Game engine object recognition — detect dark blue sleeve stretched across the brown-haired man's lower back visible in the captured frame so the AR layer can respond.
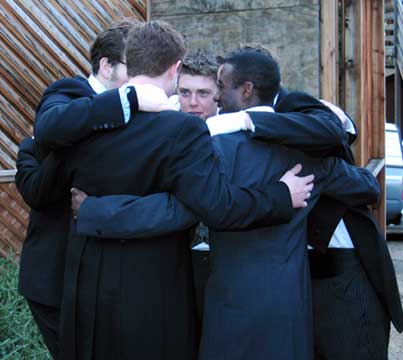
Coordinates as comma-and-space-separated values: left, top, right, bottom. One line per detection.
77, 193, 198, 239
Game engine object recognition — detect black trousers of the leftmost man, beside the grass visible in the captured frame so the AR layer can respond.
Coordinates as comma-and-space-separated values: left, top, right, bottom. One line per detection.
26, 299, 60, 359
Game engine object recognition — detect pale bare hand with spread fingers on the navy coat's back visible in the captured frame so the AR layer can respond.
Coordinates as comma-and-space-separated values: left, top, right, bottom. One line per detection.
280, 164, 314, 209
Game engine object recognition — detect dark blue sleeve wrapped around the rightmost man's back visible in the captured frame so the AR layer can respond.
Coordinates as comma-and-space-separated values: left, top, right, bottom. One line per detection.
323, 158, 381, 207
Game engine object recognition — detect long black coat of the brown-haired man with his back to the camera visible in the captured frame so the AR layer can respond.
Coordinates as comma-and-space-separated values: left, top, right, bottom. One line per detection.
54, 99, 293, 359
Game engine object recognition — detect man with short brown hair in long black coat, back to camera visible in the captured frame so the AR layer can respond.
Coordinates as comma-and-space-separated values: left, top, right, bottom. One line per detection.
35, 22, 318, 360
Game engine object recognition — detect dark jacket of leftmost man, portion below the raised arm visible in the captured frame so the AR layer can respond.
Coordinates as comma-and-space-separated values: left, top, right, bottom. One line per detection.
15, 138, 70, 307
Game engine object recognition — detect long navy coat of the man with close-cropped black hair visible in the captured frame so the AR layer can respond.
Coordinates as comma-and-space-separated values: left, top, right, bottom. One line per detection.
200, 128, 379, 360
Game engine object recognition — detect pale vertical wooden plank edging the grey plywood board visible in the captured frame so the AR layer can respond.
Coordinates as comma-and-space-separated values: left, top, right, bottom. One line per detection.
320, 1, 338, 104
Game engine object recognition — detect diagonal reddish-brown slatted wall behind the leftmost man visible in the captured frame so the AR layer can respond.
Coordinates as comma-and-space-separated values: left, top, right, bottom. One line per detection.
0, 0, 147, 254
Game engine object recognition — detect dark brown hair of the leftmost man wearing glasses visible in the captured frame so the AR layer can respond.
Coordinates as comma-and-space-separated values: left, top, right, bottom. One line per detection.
90, 19, 141, 75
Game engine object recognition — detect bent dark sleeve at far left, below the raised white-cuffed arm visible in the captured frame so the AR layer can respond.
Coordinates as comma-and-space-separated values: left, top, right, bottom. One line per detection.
15, 138, 66, 210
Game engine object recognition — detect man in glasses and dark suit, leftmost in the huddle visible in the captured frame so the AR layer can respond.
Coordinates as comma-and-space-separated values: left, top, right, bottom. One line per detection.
16, 21, 152, 357
